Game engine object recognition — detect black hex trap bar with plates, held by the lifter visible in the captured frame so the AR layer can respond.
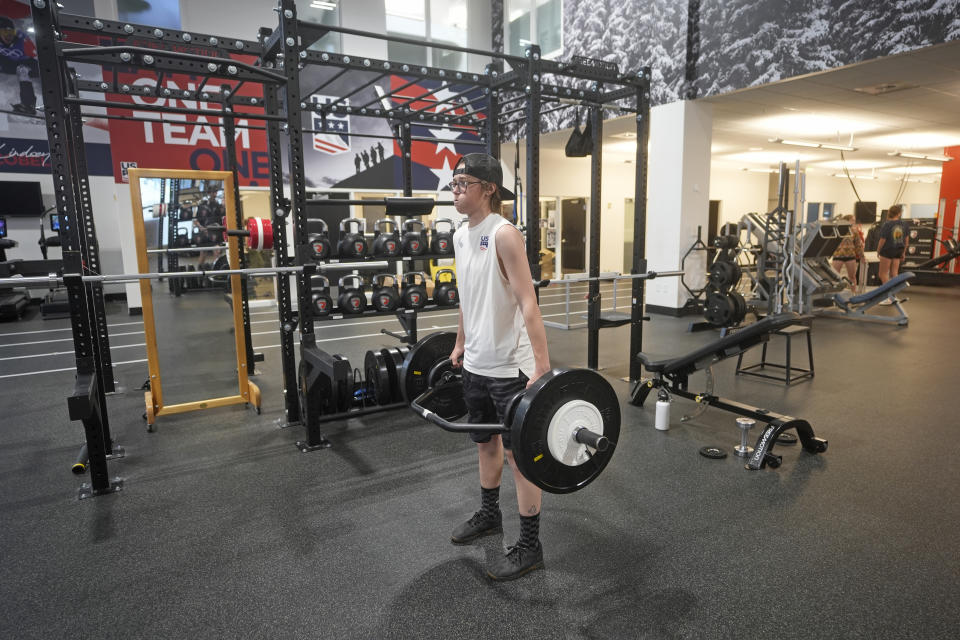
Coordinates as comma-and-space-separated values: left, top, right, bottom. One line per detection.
400, 332, 620, 493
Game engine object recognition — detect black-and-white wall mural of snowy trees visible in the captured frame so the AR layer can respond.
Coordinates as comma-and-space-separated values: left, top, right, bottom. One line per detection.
524, 0, 960, 130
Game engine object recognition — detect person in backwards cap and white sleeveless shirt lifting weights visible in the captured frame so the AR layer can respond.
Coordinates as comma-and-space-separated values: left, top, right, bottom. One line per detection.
450, 153, 550, 580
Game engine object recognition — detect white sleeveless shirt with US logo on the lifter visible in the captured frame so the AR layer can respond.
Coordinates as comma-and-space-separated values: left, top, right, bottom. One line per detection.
453, 213, 534, 378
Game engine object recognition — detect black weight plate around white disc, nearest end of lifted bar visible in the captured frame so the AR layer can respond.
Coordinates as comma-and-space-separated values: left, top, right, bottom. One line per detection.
510, 369, 620, 493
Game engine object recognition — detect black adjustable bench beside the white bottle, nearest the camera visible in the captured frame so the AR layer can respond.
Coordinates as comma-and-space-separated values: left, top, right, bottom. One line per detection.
630, 313, 827, 470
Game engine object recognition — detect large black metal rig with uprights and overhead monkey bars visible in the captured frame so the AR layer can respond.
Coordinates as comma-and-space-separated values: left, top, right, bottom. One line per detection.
31, 0, 650, 495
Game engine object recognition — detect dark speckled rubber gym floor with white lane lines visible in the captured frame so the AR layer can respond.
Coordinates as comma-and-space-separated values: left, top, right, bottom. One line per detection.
0, 287, 960, 639
